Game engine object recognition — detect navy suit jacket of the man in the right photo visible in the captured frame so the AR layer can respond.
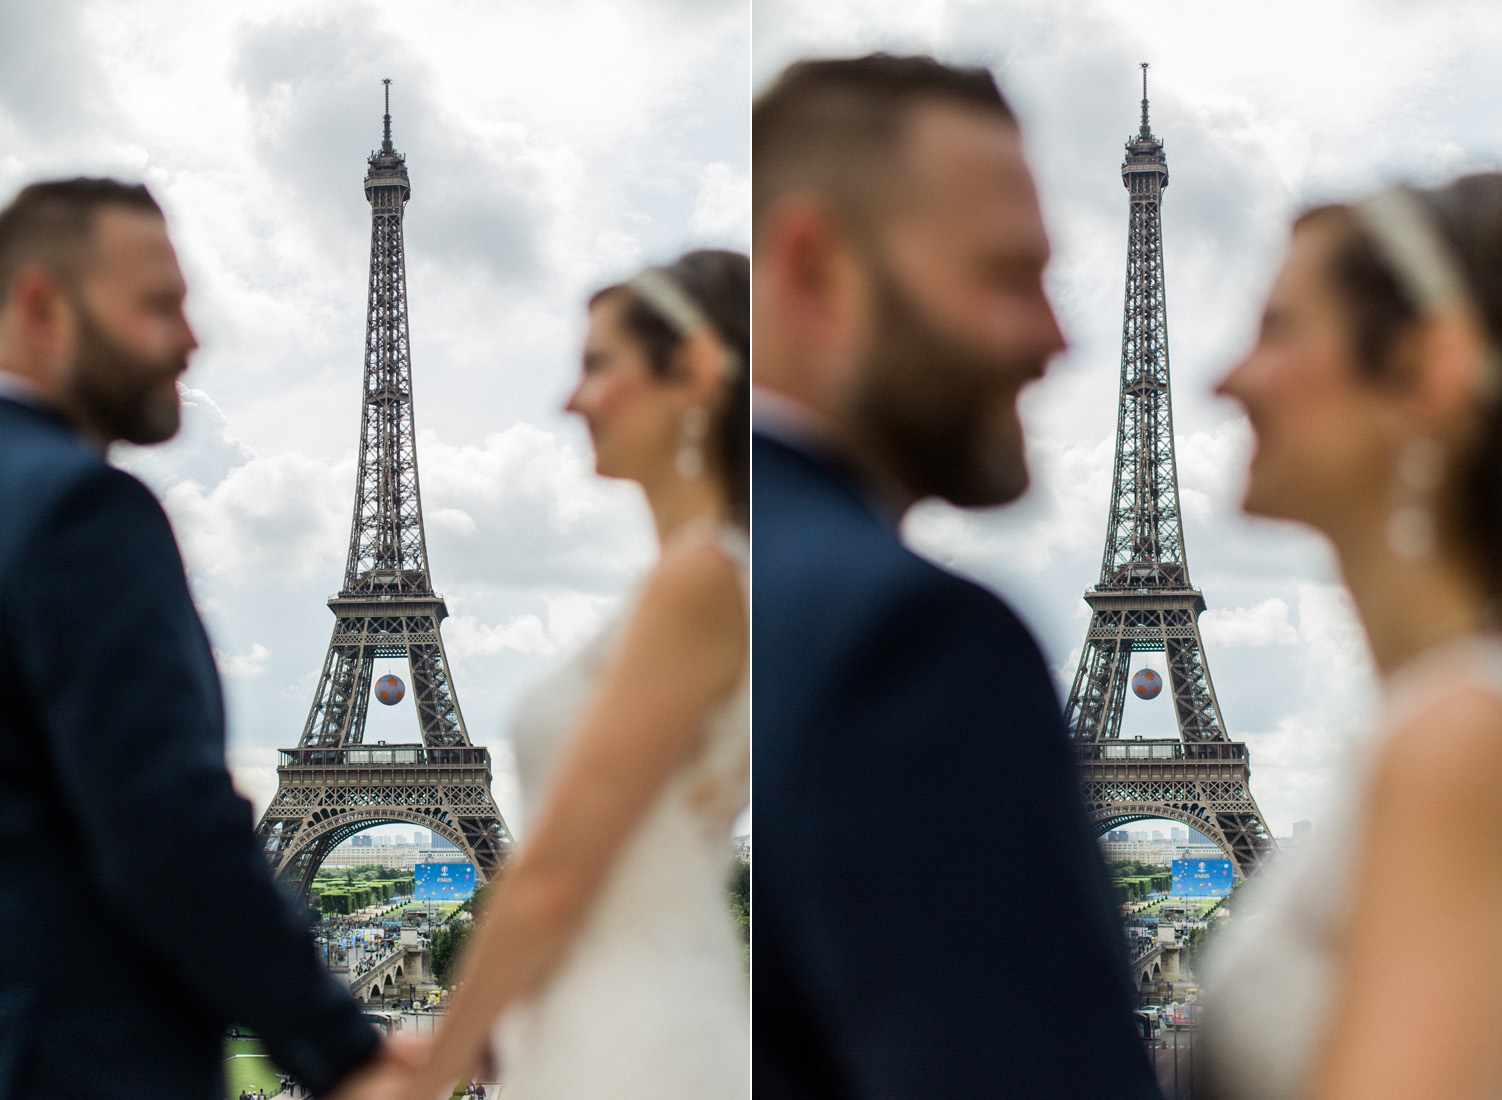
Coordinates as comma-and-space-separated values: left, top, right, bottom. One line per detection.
751, 436, 1158, 1100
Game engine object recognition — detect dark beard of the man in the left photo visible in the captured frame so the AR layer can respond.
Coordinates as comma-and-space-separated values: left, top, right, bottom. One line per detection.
66, 296, 188, 443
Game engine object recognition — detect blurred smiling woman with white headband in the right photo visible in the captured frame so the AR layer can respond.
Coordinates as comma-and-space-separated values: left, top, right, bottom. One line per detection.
1205, 174, 1502, 1100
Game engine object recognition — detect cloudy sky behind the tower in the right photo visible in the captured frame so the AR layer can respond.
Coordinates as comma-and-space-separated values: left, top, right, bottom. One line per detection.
753, 0, 1502, 836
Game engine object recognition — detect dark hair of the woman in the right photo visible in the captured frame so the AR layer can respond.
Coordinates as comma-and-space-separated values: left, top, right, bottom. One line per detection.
1295, 173, 1502, 597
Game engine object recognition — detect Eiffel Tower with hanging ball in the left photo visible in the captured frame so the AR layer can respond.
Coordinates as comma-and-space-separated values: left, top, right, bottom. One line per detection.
257, 80, 511, 897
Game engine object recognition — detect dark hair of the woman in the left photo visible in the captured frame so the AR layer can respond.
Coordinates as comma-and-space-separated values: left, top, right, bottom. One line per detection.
589, 249, 751, 524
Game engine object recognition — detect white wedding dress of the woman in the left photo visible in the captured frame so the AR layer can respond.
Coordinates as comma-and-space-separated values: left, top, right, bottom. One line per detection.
496, 529, 751, 1100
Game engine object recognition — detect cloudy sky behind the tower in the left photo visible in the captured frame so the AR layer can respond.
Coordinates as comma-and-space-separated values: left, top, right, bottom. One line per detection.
0, 0, 749, 831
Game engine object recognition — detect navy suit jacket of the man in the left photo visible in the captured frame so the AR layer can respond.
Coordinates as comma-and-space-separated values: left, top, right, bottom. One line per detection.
0, 398, 379, 1100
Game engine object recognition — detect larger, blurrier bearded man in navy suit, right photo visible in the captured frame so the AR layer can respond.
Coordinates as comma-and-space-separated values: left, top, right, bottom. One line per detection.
753, 56, 1157, 1100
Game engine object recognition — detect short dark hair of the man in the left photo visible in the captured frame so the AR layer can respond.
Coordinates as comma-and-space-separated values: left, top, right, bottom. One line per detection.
0, 177, 162, 301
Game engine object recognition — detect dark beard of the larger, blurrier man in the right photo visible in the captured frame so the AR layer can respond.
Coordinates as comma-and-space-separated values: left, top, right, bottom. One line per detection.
850, 260, 1044, 508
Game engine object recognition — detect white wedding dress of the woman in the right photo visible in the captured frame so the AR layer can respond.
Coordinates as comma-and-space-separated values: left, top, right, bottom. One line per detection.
1202, 636, 1502, 1100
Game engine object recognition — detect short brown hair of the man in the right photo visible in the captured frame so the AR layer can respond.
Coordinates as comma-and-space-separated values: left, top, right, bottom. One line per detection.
751, 54, 1017, 234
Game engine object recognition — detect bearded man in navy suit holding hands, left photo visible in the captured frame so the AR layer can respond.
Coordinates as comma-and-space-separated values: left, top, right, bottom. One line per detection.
0, 179, 402, 1100
